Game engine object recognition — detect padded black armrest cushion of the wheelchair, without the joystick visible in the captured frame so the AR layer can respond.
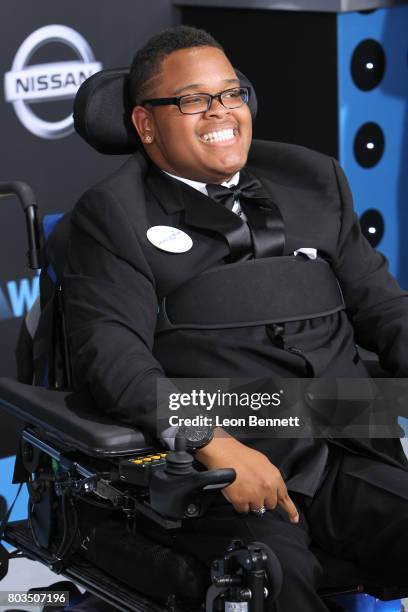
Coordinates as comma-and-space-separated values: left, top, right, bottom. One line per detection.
0, 378, 152, 457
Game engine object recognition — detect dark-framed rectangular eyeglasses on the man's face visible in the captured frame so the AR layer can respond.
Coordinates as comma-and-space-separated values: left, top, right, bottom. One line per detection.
142, 87, 250, 115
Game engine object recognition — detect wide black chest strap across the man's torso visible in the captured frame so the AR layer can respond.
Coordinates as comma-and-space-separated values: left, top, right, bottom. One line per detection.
156, 256, 345, 333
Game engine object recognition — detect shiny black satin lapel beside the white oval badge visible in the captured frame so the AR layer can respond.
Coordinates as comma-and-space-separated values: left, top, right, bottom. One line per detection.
146, 166, 251, 261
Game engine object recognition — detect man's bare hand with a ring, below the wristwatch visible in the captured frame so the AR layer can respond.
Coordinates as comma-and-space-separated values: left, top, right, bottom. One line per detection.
196, 430, 299, 523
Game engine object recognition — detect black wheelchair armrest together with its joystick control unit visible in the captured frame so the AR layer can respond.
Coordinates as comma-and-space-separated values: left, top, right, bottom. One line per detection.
0, 378, 235, 527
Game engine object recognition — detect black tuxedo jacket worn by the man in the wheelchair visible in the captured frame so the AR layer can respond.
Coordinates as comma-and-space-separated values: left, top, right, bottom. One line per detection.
64, 141, 408, 494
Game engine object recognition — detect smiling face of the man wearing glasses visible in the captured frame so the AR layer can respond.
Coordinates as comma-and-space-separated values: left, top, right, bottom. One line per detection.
132, 47, 252, 183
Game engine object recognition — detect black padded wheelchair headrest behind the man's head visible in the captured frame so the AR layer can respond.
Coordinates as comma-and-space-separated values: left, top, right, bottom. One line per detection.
74, 69, 258, 155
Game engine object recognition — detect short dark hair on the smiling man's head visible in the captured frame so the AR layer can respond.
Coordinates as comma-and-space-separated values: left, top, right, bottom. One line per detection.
129, 25, 224, 105
